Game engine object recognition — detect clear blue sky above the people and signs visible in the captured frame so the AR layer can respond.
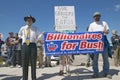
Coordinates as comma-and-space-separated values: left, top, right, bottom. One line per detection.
0, 0, 120, 40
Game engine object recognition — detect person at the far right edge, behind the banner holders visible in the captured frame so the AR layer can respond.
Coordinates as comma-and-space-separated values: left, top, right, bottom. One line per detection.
111, 30, 120, 67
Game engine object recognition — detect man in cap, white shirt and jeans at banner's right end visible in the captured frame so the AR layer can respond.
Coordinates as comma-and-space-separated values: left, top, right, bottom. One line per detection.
88, 12, 111, 78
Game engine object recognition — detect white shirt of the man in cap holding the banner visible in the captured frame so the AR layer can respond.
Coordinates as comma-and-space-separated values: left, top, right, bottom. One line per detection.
88, 21, 109, 32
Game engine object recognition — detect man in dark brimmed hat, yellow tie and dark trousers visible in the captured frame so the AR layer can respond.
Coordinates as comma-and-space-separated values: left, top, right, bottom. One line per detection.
18, 16, 39, 80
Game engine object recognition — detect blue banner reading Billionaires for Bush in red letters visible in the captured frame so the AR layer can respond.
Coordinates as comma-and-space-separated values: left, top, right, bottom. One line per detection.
44, 32, 104, 55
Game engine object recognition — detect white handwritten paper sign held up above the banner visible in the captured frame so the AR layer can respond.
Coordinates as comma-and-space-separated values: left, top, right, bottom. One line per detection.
55, 6, 76, 31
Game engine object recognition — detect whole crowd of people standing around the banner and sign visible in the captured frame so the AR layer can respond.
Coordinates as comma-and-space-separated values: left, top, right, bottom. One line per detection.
0, 12, 120, 80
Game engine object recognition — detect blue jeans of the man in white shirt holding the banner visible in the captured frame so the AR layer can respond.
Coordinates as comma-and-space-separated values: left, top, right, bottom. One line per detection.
93, 47, 109, 74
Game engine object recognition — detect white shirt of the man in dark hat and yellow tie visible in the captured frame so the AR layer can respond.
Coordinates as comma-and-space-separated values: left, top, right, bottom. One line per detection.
18, 25, 40, 43
